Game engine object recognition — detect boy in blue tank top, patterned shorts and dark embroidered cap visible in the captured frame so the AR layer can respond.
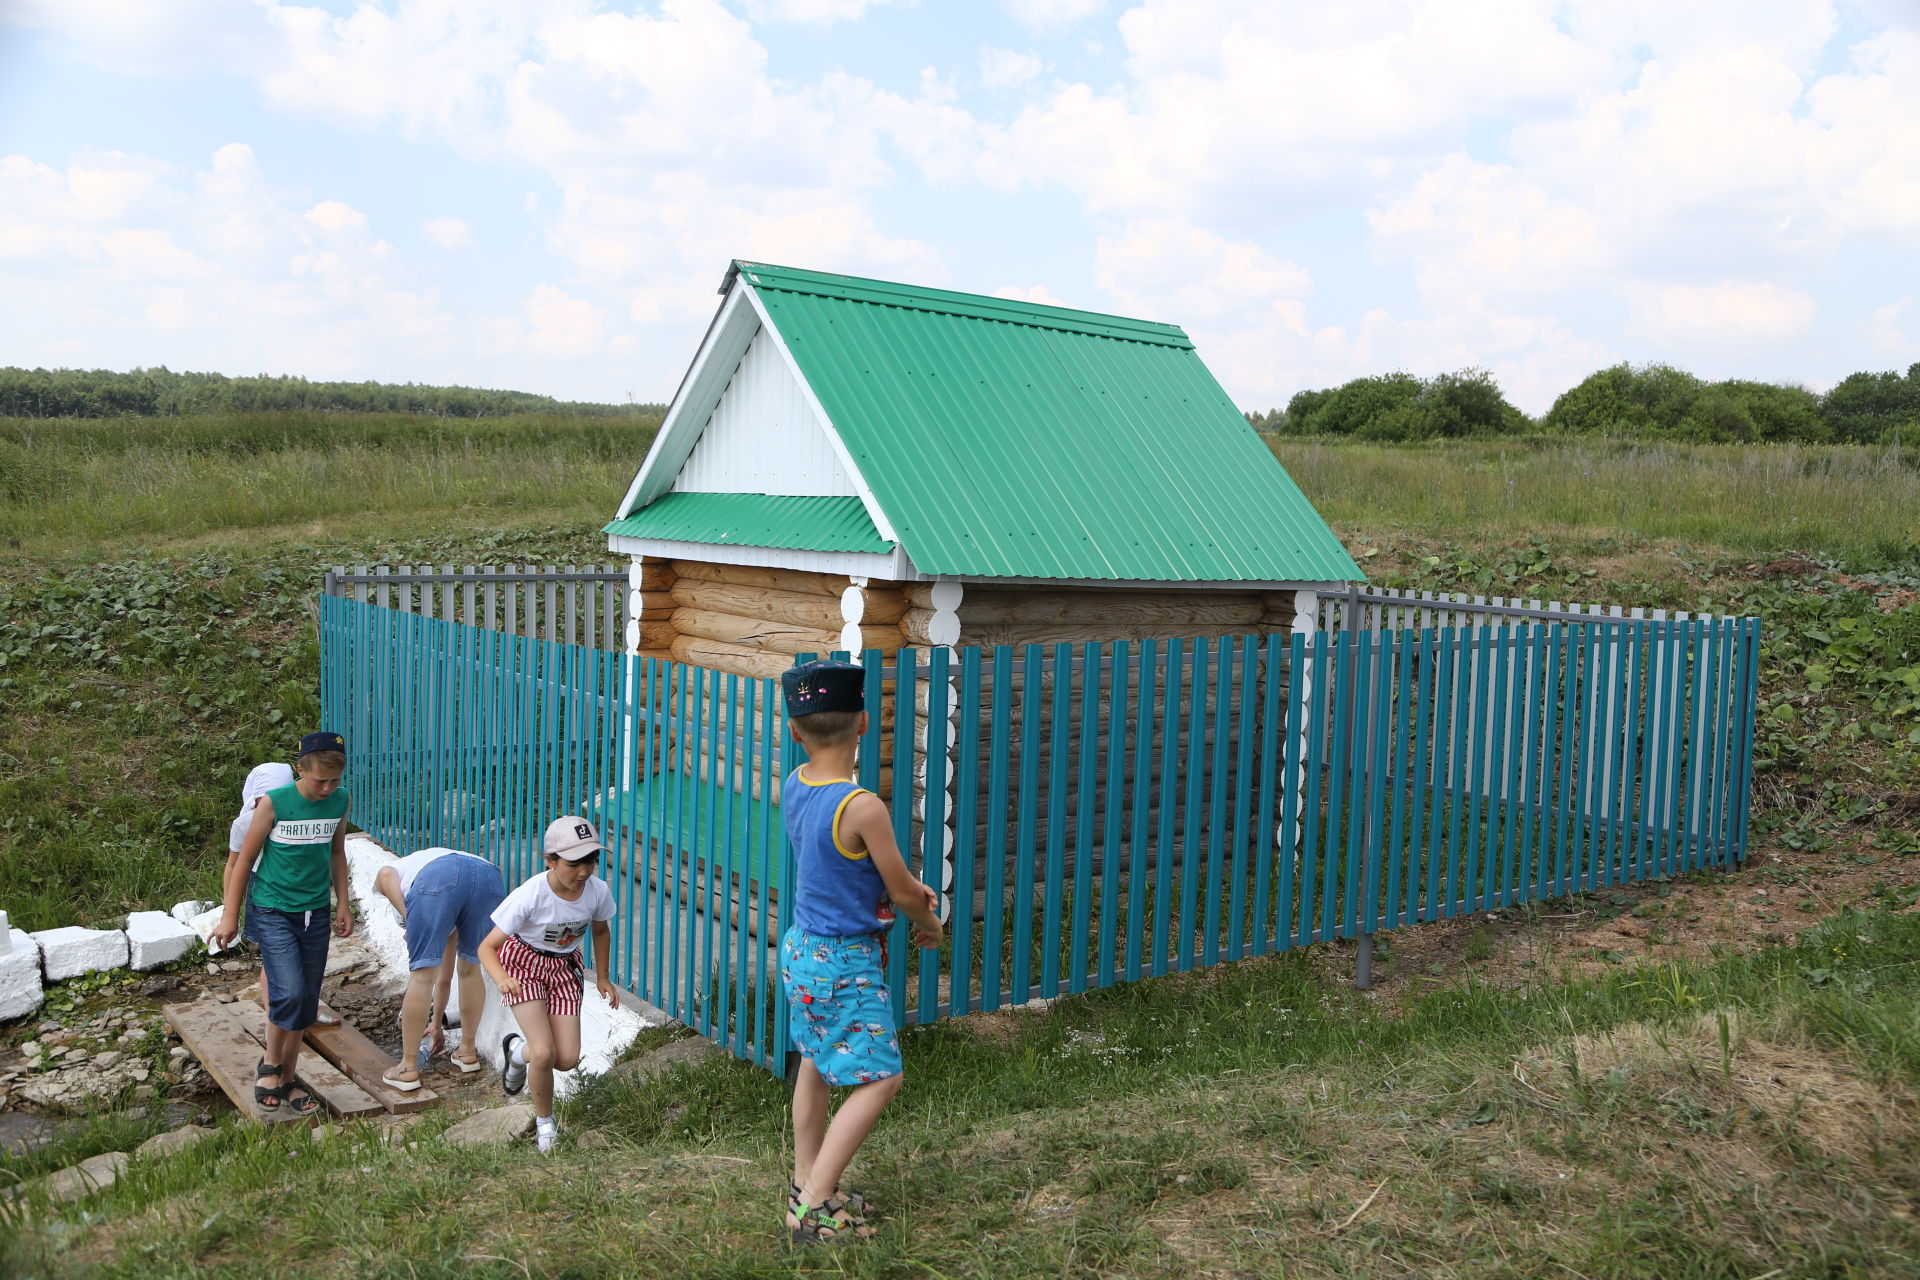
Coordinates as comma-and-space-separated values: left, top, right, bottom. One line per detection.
780, 662, 941, 1244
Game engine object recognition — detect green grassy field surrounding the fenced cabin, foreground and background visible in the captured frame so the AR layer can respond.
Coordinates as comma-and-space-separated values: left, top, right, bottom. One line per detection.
0, 415, 1920, 1280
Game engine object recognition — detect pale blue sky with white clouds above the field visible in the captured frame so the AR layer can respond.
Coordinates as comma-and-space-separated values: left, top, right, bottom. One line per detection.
0, 0, 1920, 413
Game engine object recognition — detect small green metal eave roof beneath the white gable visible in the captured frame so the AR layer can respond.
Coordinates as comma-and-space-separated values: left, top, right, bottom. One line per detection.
603, 493, 893, 553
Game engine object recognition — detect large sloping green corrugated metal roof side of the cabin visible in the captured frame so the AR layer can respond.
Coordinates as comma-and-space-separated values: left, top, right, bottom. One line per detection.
737, 263, 1365, 581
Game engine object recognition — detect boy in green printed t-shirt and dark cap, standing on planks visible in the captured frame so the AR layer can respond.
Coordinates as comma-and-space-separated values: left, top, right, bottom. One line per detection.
207, 733, 353, 1115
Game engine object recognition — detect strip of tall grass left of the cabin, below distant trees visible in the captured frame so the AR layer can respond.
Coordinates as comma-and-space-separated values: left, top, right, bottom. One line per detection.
0, 413, 657, 551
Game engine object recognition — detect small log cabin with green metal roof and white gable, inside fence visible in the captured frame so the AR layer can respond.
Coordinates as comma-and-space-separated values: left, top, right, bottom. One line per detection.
607, 261, 1363, 912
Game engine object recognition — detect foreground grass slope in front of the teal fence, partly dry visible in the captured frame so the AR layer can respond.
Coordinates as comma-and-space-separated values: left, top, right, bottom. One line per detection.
0, 913, 1920, 1280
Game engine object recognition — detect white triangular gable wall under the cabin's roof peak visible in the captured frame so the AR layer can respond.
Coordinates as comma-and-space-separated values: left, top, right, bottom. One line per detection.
674, 328, 858, 497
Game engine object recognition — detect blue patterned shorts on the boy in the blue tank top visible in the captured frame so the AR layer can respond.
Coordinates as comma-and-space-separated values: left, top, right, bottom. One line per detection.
780, 927, 904, 1084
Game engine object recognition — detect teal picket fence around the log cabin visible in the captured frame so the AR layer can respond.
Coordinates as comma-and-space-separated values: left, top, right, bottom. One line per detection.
321, 595, 1759, 1069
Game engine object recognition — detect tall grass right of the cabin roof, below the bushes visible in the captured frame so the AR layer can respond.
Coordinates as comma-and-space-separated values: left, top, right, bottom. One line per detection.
1271, 438, 1920, 558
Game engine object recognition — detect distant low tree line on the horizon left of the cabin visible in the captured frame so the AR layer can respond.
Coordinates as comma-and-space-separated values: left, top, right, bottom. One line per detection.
0, 367, 660, 418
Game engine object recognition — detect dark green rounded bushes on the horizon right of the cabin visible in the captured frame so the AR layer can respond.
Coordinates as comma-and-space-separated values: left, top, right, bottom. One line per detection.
1246, 363, 1920, 443
